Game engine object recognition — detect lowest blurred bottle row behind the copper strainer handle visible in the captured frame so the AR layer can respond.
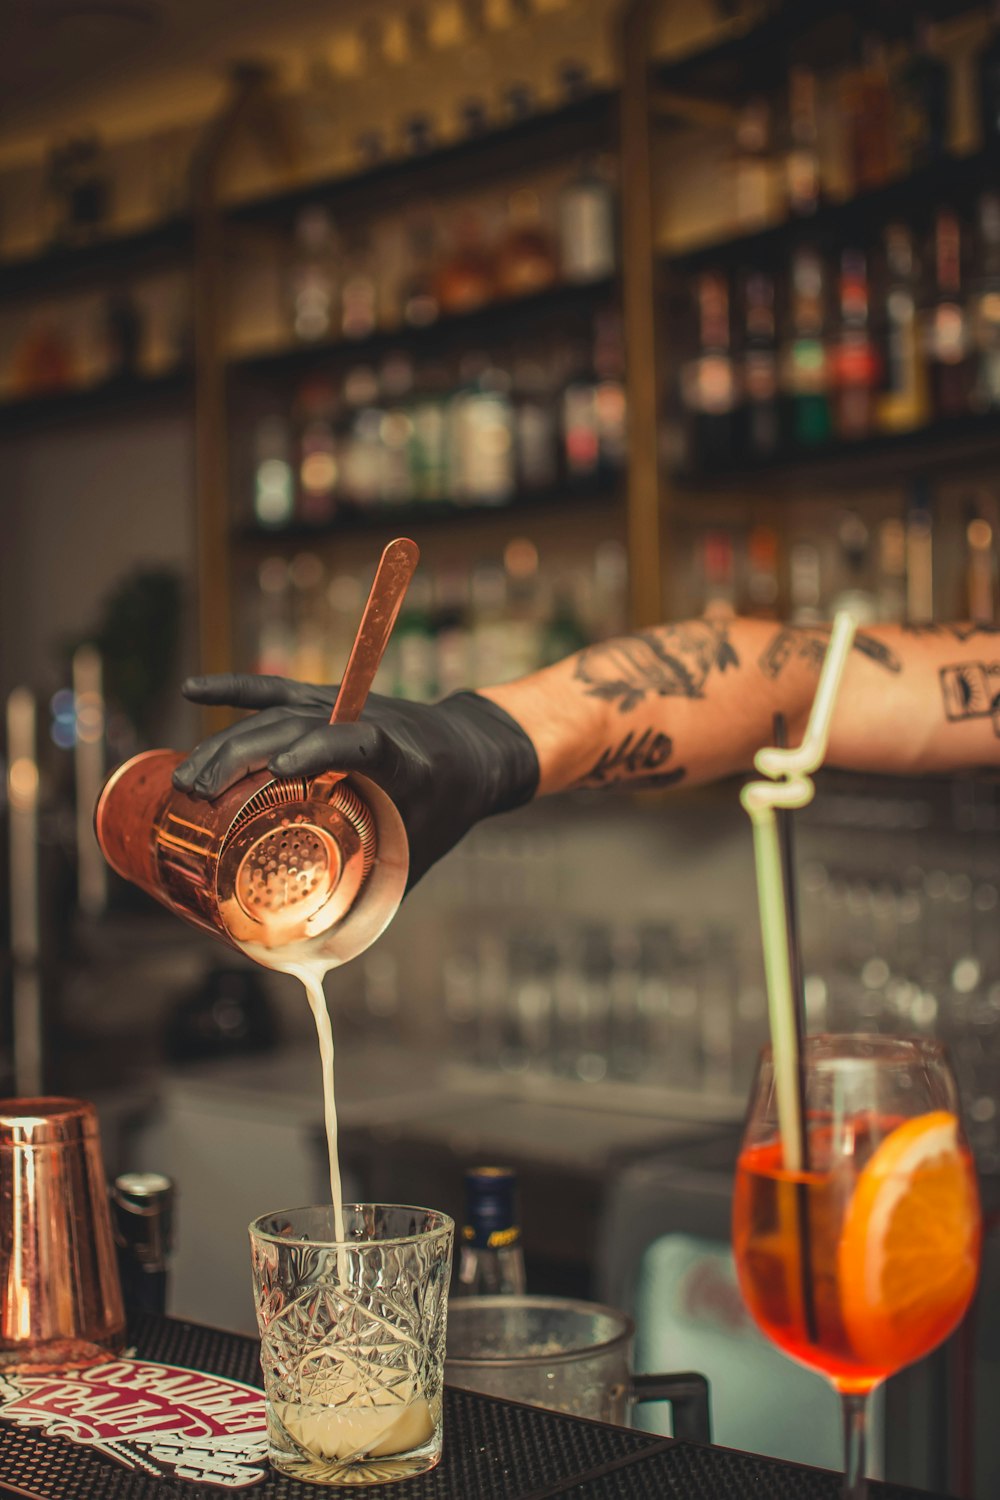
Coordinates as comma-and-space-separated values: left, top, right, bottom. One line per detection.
250, 537, 627, 701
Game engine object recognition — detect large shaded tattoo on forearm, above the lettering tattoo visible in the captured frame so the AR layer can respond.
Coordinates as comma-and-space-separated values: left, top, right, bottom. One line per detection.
573, 620, 739, 714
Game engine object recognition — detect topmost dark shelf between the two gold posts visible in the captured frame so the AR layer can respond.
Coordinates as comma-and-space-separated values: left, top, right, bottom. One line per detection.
228, 89, 618, 227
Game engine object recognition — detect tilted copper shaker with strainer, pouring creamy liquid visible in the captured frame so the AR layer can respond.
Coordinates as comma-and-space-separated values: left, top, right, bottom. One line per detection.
96, 539, 418, 968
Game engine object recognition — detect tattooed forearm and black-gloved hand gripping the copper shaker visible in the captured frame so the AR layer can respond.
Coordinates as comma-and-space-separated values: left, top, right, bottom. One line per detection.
174, 618, 1000, 885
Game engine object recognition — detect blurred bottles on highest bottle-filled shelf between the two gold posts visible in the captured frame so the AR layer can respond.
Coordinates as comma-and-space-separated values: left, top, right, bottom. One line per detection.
275, 156, 616, 351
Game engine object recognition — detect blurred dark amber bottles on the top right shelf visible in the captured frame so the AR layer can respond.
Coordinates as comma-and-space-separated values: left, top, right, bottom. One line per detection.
719, 6, 1000, 231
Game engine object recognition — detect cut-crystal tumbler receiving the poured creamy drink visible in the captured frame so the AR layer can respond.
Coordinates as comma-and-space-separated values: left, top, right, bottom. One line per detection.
250, 1203, 454, 1485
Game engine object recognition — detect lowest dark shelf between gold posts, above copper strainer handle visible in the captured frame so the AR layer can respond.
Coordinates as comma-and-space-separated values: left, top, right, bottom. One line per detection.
232, 476, 625, 551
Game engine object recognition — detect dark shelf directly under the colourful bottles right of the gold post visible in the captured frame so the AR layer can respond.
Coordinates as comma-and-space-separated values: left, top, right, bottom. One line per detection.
672, 411, 1000, 494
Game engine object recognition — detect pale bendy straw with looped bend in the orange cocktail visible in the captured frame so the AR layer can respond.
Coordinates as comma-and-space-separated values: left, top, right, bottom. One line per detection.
739, 611, 856, 1172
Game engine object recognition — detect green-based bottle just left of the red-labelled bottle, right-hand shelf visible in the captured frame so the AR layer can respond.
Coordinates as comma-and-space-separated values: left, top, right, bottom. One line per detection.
781, 245, 831, 447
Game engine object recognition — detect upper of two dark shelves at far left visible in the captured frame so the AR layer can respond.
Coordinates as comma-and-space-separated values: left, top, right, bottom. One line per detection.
0, 218, 193, 299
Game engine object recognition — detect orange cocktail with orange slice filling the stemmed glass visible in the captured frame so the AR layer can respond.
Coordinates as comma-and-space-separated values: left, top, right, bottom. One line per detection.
733, 1110, 979, 1392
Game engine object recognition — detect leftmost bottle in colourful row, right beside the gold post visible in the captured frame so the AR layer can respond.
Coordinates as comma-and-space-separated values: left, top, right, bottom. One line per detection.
681, 270, 736, 470
